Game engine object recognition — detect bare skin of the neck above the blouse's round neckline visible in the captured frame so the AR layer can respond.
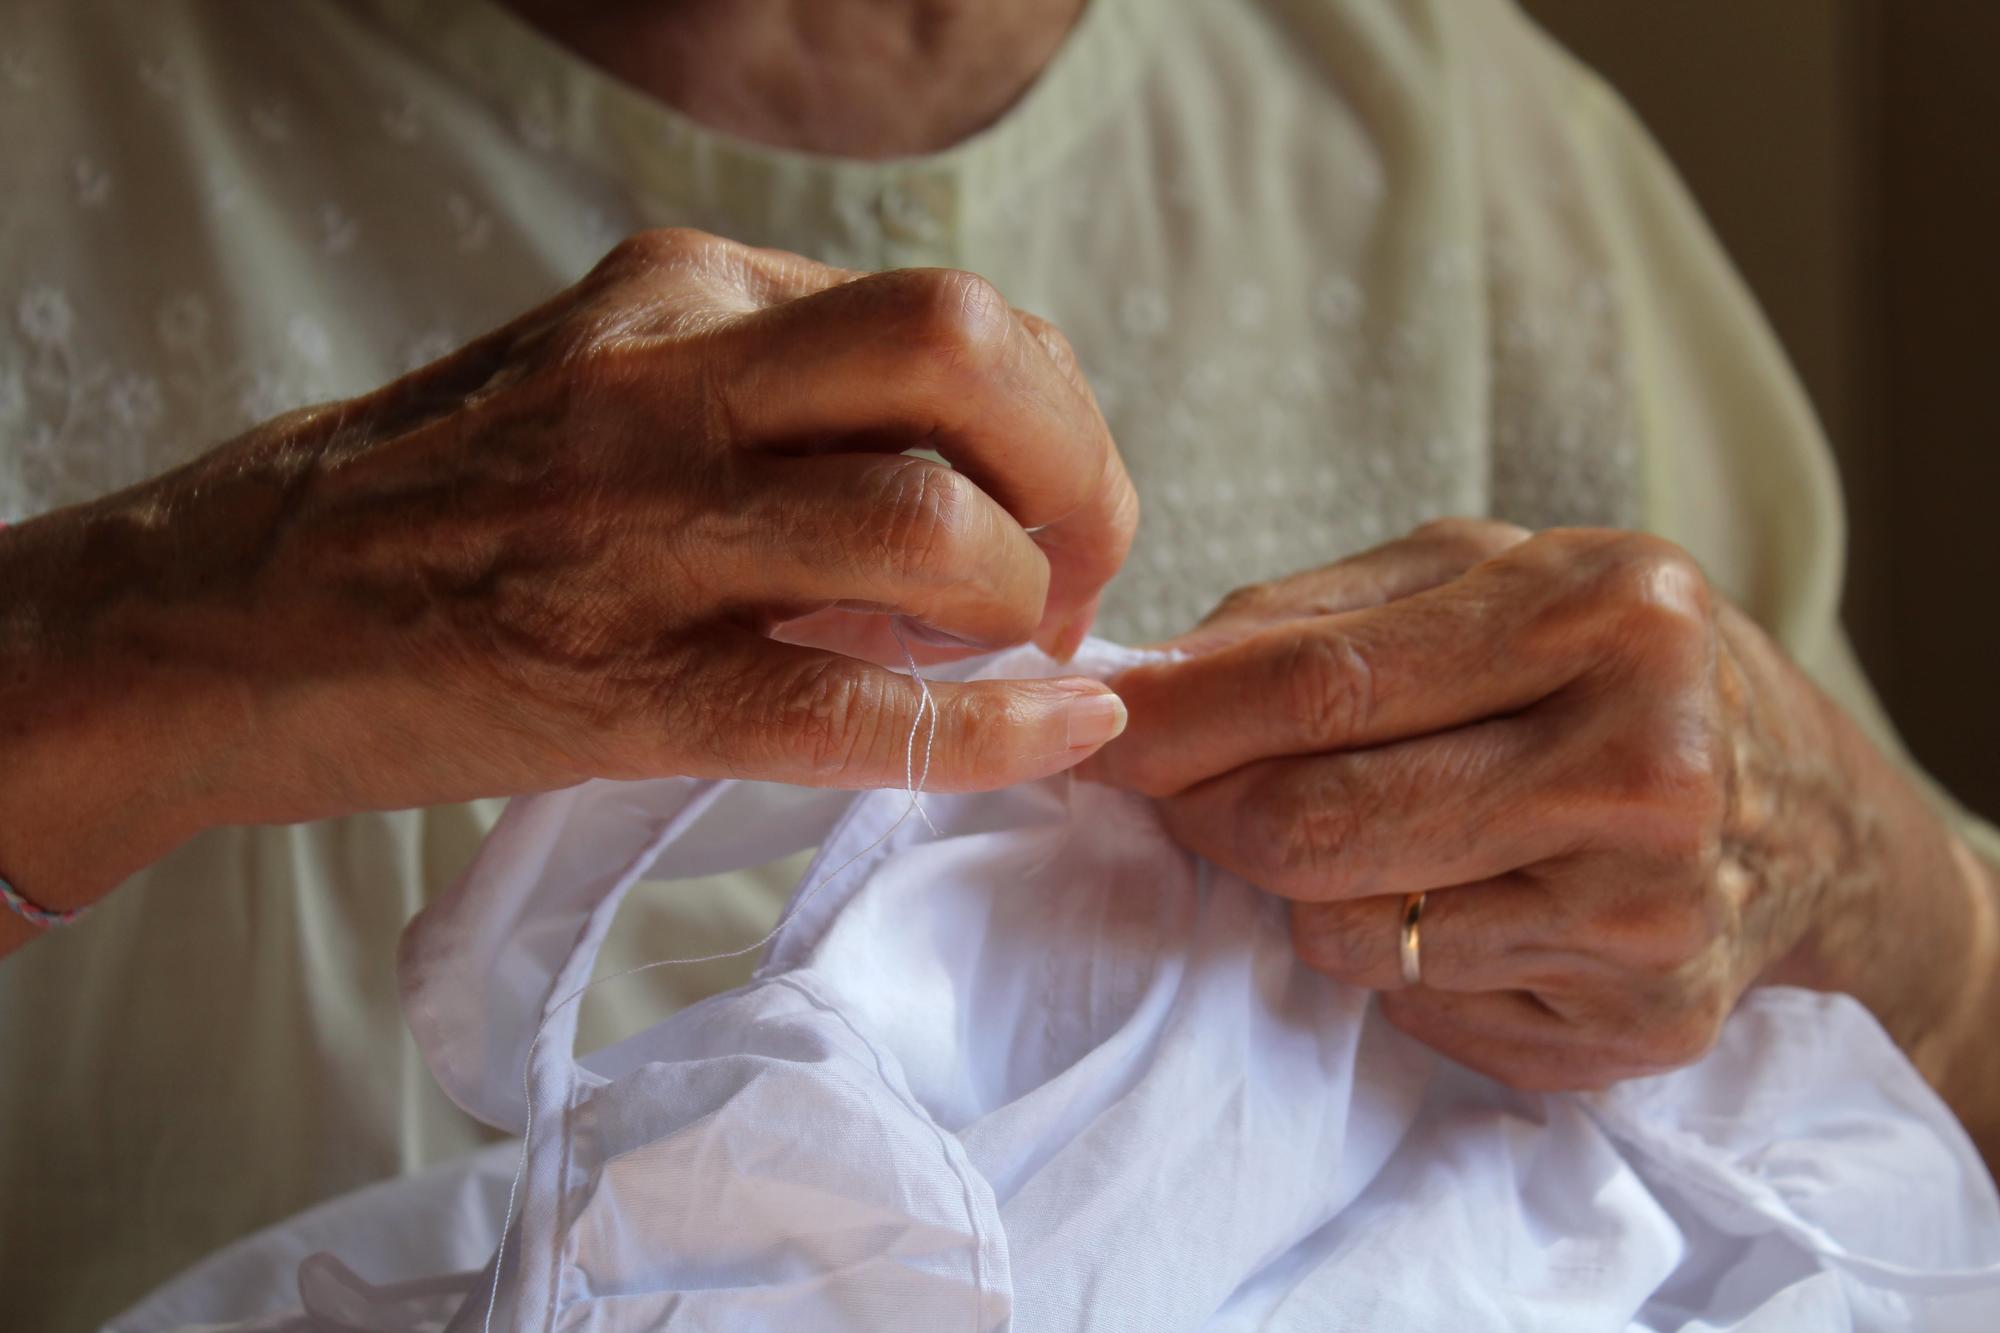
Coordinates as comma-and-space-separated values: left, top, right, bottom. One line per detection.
504, 0, 1084, 158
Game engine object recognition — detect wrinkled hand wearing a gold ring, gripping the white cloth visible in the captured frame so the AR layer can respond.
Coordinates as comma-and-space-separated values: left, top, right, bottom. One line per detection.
1086, 520, 2000, 1112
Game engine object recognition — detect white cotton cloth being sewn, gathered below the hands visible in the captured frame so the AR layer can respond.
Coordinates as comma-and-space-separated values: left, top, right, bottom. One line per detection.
114, 642, 2000, 1333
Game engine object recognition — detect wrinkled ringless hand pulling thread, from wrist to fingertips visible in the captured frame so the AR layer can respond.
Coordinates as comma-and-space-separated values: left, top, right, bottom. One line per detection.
227, 232, 1136, 805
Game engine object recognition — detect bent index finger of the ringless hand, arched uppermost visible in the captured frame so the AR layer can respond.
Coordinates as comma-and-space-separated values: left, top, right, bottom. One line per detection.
710, 268, 1138, 654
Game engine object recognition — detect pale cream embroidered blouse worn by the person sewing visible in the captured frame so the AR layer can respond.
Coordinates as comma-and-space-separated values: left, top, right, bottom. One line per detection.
15, 0, 2000, 1333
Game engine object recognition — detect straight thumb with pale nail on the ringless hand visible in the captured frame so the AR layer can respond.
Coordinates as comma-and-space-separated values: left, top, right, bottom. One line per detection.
696, 636, 1126, 791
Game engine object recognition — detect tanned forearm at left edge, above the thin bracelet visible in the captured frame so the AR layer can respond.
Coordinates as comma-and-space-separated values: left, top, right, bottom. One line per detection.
0, 404, 352, 951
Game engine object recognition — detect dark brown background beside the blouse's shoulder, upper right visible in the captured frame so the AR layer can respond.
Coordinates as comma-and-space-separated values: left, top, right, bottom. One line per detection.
1524, 0, 2000, 817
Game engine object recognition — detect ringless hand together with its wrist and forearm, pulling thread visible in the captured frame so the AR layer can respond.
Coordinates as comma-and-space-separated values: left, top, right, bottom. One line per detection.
0, 232, 1136, 928
